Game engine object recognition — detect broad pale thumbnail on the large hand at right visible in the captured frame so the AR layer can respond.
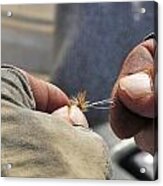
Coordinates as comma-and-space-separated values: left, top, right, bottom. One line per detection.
119, 72, 152, 99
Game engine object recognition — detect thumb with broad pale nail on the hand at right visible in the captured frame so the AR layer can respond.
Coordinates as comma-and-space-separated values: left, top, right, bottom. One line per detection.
118, 71, 156, 118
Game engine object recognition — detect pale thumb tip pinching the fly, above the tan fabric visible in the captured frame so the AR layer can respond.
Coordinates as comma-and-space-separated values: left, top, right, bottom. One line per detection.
52, 105, 88, 128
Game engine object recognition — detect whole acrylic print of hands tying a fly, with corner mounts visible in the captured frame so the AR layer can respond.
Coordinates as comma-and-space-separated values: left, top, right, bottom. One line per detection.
1, 1, 158, 181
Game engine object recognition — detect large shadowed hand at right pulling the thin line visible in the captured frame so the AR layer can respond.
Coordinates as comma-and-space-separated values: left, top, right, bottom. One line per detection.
110, 39, 157, 154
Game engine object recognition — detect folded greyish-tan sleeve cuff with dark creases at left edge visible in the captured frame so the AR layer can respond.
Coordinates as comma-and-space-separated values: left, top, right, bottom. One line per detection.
1, 64, 36, 109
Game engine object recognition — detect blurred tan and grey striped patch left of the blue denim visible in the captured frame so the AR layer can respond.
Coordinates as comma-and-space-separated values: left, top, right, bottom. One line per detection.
1, 5, 56, 78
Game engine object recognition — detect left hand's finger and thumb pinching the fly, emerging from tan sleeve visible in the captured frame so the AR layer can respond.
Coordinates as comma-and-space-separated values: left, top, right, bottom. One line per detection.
21, 70, 88, 127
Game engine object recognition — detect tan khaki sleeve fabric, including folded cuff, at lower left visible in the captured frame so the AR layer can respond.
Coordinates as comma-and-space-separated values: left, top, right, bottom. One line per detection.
1, 66, 111, 179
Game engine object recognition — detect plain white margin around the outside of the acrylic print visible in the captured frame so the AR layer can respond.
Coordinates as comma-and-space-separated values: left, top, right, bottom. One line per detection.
0, 0, 163, 186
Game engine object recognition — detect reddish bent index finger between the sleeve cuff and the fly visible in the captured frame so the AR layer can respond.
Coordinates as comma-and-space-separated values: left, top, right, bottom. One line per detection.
23, 71, 69, 113
